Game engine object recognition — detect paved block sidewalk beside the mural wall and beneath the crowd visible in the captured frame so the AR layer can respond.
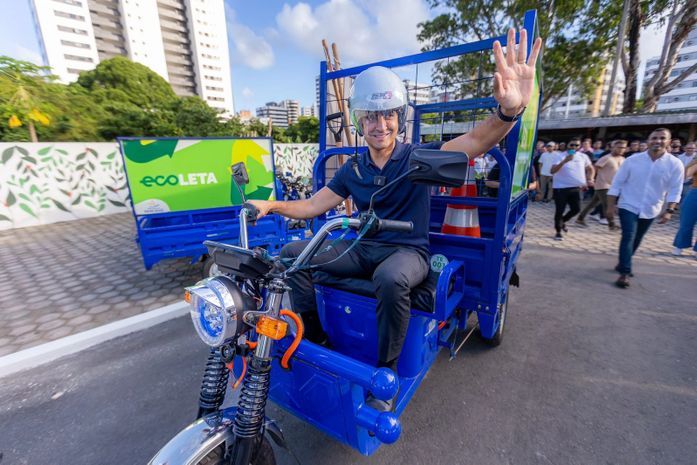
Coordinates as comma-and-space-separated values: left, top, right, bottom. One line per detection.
0, 203, 697, 356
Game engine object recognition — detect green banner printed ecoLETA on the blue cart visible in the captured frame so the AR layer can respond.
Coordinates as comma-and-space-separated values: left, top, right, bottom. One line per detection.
121, 139, 275, 215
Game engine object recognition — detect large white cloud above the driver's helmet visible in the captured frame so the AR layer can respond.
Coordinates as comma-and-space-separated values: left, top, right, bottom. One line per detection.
276, 0, 428, 65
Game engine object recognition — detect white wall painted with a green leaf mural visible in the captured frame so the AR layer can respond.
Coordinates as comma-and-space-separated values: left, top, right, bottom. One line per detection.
0, 142, 319, 230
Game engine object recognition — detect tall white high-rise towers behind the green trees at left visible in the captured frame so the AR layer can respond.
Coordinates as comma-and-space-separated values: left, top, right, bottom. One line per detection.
31, 0, 234, 116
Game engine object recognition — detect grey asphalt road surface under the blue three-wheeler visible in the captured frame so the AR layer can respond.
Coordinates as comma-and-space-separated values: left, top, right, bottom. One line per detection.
0, 245, 697, 465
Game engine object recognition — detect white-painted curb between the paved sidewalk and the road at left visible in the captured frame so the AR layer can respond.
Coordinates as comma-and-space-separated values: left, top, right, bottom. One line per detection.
0, 302, 189, 378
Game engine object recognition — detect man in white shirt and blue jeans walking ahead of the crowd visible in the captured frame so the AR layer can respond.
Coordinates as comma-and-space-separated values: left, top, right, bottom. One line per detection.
607, 128, 685, 288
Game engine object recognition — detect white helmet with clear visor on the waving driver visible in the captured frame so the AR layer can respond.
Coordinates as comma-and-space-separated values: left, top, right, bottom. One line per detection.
349, 66, 409, 136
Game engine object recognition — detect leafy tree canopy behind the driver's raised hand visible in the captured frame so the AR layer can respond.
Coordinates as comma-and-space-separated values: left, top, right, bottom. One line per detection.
418, 0, 622, 108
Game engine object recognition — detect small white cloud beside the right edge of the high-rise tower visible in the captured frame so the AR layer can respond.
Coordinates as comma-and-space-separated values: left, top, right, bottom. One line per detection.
225, 4, 274, 69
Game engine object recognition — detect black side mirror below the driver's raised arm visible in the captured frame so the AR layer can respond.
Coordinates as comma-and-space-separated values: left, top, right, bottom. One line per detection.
409, 149, 469, 187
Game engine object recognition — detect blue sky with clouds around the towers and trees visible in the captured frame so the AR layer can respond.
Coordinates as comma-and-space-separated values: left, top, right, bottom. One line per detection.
0, 0, 662, 112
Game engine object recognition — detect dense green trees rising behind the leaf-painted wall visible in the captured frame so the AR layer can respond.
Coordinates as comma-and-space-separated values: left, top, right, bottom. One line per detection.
0, 56, 296, 141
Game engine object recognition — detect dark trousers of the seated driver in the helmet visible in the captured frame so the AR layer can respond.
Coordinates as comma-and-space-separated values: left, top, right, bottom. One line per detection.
281, 241, 428, 367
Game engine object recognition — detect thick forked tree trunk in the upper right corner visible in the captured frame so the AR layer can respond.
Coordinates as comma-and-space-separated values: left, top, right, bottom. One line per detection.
642, 0, 697, 112
